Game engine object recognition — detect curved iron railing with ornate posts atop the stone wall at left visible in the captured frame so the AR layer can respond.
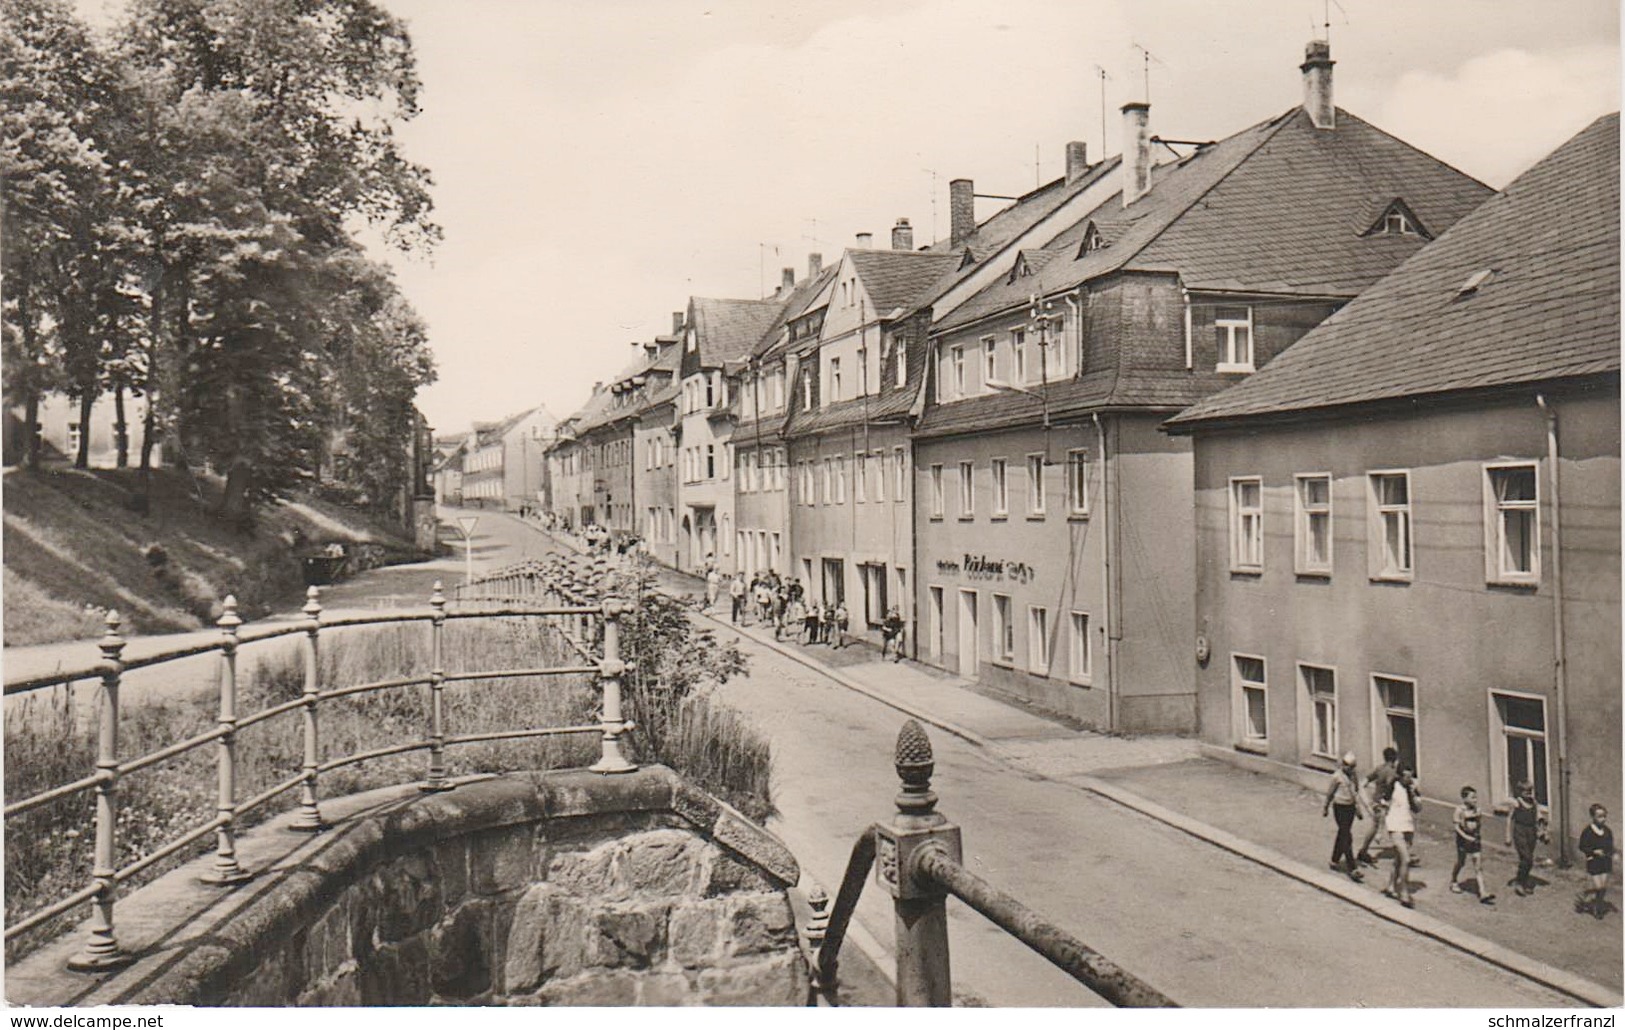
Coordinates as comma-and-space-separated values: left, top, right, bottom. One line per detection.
3, 575, 635, 972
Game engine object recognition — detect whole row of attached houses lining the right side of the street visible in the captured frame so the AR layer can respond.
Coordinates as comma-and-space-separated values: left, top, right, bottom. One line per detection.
548, 42, 1620, 844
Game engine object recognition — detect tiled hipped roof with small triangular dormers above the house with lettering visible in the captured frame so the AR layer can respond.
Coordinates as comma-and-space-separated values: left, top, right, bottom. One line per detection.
938, 107, 1490, 330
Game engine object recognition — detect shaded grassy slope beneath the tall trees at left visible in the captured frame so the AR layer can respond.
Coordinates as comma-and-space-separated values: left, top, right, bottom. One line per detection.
3, 468, 418, 645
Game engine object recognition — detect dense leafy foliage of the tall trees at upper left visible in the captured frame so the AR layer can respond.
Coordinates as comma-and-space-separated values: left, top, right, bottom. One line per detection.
0, 0, 440, 518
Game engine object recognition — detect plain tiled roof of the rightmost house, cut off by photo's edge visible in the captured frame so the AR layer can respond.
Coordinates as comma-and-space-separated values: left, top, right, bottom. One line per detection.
1170, 114, 1620, 429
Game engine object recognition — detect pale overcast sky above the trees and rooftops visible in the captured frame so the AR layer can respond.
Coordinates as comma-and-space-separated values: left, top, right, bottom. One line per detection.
155, 0, 1620, 432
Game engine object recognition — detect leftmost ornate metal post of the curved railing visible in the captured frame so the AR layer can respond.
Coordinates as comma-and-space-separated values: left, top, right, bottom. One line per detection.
68, 611, 133, 972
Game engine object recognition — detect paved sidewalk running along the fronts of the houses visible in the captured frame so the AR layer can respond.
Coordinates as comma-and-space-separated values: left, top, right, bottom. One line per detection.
707, 606, 1625, 1006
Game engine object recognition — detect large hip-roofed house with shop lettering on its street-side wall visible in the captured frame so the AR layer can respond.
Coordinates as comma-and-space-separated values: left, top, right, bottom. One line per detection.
913, 42, 1490, 731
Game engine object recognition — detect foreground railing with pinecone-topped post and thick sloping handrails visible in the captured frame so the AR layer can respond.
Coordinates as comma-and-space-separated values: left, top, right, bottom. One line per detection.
808, 720, 1177, 1007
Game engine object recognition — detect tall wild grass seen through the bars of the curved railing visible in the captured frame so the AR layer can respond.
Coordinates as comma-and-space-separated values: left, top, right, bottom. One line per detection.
5, 604, 770, 960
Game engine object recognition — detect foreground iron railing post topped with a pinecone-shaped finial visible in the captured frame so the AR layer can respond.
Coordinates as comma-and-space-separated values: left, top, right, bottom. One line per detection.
874, 720, 960, 1007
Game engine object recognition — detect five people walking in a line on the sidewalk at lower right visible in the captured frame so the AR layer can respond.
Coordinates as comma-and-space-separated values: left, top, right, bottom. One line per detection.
1321, 747, 1614, 920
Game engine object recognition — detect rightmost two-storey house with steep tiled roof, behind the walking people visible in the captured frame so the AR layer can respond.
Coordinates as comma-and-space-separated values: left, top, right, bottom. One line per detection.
1168, 114, 1620, 845
